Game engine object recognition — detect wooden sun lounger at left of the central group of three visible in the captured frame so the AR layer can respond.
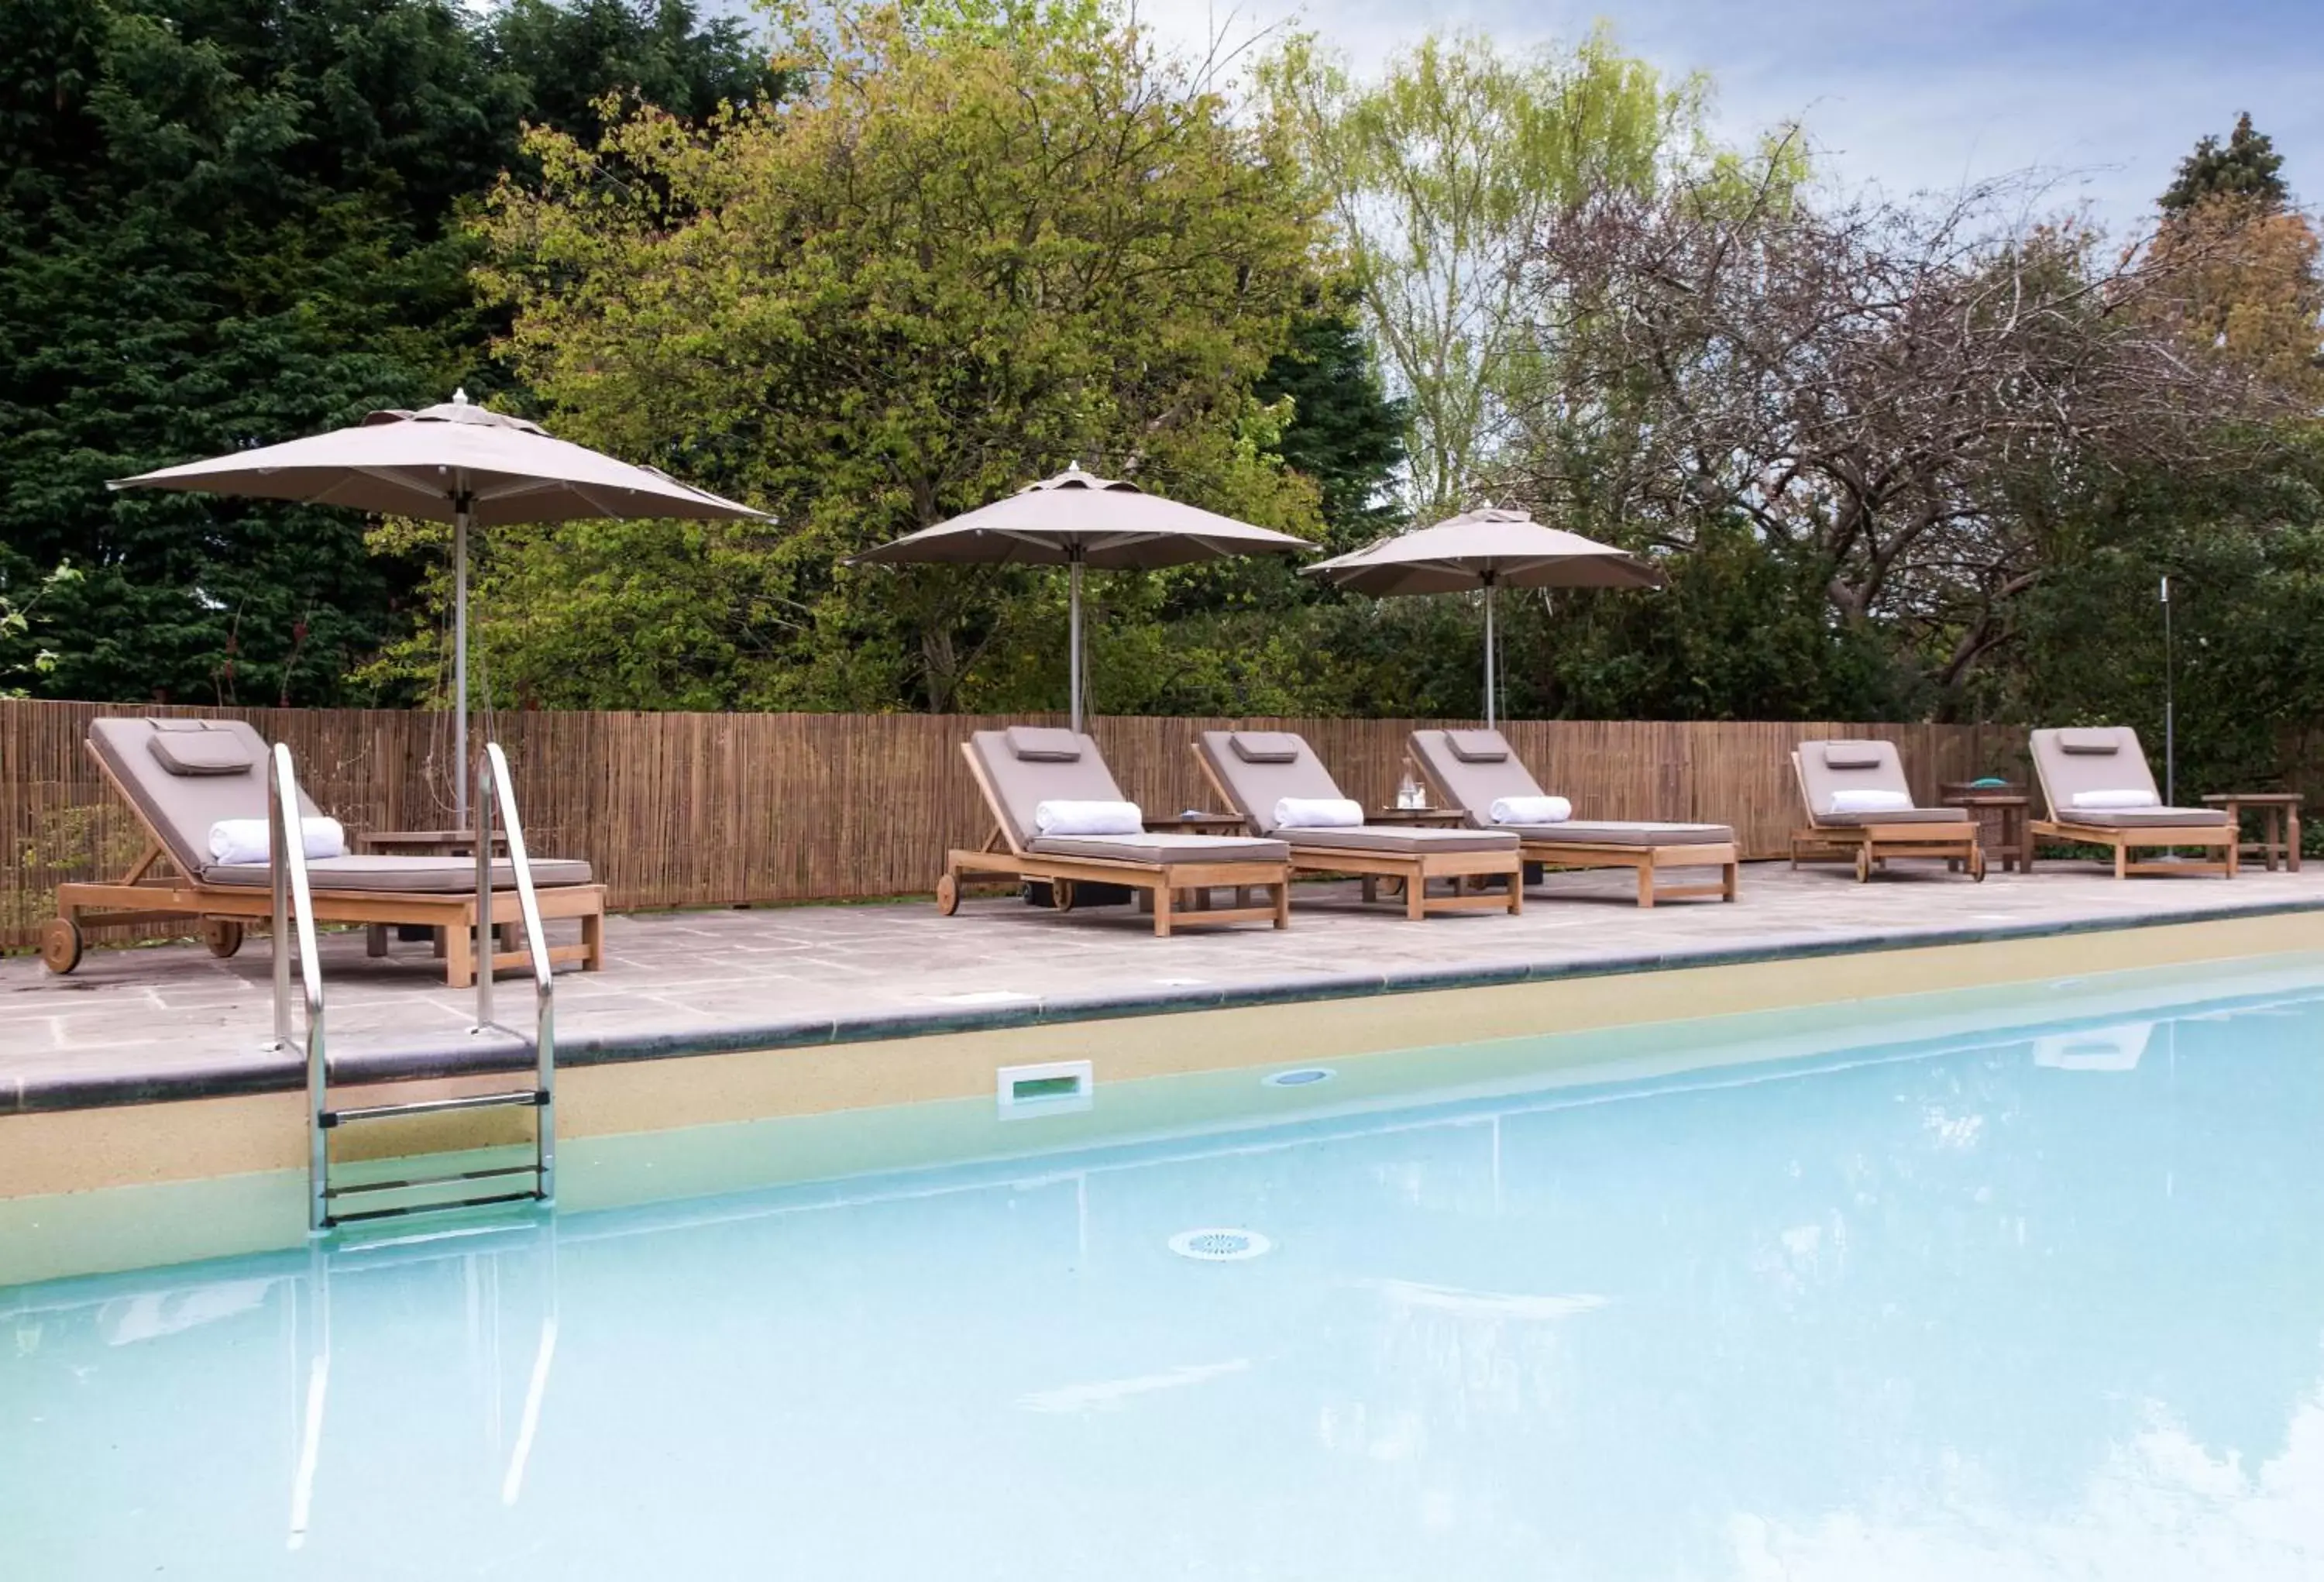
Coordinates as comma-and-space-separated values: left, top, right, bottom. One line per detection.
937, 725, 1292, 936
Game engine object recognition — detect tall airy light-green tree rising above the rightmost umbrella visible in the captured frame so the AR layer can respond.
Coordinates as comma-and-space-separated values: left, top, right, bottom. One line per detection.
1267, 33, 1703, 516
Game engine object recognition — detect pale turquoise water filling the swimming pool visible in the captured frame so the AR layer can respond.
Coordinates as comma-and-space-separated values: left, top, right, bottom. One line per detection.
0, 971, 2324, 1582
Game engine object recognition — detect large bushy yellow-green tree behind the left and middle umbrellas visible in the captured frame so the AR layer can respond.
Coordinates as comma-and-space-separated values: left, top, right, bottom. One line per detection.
483, 5, 1315, 709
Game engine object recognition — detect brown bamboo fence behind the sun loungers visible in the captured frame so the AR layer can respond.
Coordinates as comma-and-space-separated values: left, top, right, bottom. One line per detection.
0, 702, 2024, 947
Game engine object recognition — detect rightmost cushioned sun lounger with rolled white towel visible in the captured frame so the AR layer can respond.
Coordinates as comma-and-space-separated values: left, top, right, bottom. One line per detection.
2027, 725, 2238, 878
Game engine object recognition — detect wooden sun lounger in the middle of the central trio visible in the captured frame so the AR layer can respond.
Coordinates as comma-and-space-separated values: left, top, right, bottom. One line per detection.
1195, 730, 1525, 922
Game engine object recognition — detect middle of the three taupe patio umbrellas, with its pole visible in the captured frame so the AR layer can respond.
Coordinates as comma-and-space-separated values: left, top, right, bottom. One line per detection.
853, 463, 1315, 730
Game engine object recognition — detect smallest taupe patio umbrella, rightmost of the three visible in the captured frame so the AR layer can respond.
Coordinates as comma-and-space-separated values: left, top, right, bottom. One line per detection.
1301, 507, 1662, 725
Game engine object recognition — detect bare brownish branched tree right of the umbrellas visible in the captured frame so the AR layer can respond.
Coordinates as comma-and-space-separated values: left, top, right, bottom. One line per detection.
1513, 160, 2280, 686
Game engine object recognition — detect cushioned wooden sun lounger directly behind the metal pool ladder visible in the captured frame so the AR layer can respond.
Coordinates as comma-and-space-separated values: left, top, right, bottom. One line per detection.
42, 718, 604, 987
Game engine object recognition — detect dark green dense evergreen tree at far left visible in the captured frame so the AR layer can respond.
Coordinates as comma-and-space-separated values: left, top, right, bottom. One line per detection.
0, 0, 781, 704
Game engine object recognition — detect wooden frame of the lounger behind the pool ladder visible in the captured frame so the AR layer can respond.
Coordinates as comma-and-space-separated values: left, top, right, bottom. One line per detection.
40, 744, 604, 989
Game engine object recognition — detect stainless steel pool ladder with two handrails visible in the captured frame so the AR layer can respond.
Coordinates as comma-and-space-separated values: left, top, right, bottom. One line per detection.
267, 741, 558, 1231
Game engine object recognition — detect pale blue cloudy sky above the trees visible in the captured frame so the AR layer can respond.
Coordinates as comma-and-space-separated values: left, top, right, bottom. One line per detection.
1136, 0, 2324, 230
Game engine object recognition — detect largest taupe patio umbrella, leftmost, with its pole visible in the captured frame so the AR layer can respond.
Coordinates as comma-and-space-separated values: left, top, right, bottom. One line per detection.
107, 390, 765, 829
